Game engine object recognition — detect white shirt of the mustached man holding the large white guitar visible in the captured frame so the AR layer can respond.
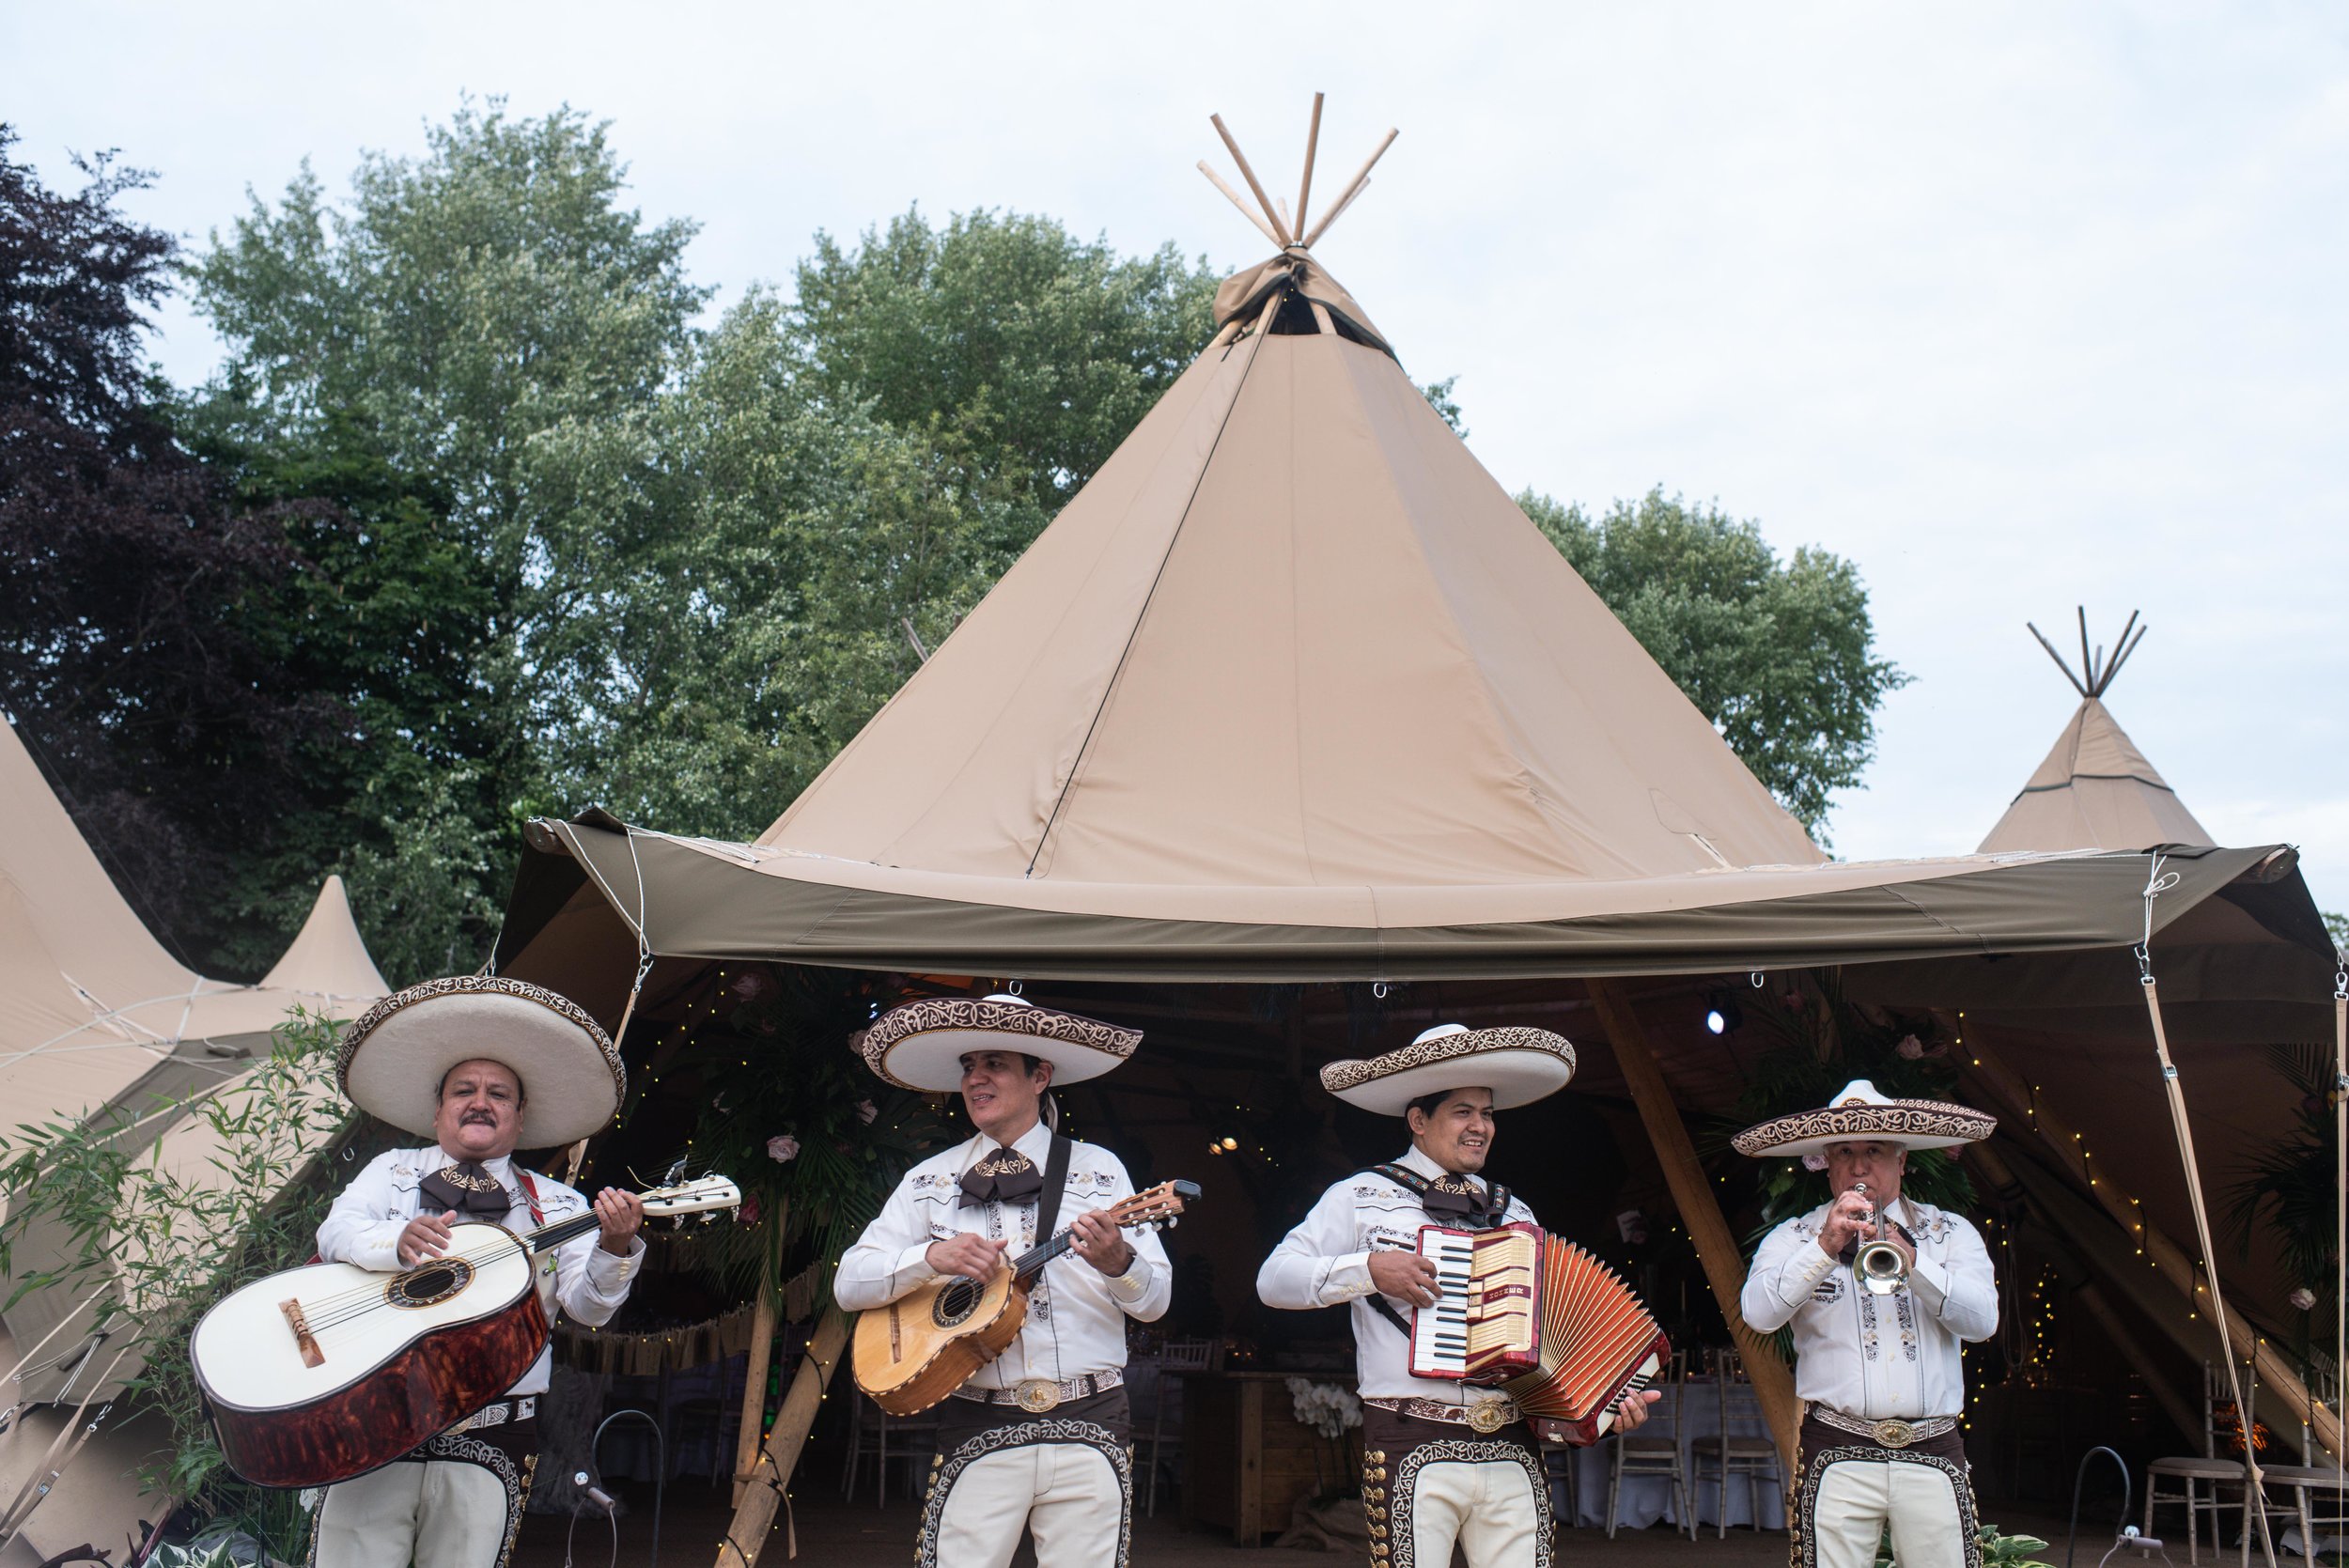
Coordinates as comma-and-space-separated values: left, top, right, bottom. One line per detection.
318, 1148, 644, 1394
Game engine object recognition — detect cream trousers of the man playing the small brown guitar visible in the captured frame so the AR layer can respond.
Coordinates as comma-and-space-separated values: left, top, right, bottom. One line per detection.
921, 1444, 1128, 1568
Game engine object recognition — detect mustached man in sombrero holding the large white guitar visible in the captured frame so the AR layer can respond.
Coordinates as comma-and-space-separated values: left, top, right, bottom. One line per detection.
310, 974, 644, 1568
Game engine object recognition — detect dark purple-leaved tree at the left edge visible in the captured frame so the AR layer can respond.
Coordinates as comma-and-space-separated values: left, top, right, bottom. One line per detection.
0, 127, 338, 951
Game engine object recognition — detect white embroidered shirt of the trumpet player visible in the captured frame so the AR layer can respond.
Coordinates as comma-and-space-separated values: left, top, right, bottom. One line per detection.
1738, 1197, 1999, 1421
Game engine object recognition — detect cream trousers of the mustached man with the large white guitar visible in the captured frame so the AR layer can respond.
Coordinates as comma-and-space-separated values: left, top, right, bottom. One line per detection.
313, 1460, 517, 1568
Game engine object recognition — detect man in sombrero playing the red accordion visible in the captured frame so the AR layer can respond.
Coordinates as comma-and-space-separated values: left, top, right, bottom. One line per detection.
1257, 1023, 1657, 1568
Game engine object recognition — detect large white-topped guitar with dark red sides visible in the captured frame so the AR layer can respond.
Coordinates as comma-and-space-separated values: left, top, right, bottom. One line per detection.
188, 1176, 742, 1486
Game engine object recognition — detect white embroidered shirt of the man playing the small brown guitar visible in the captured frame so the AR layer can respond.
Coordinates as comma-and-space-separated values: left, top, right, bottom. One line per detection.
832, 1122, 1174, 1388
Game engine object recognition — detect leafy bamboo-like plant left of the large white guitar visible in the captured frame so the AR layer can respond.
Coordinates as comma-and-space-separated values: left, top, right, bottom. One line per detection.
0, 1009, 368, 1561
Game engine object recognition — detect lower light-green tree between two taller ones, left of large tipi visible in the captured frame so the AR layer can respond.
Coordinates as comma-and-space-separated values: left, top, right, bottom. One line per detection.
531, 291, 1010, 838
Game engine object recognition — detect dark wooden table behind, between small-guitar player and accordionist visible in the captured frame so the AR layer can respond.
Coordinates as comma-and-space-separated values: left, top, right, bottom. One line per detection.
1182, 1371, 1330, 1547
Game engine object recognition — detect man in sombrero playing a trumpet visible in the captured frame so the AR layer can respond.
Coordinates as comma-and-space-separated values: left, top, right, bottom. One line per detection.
1734, 1078, 1999, 1568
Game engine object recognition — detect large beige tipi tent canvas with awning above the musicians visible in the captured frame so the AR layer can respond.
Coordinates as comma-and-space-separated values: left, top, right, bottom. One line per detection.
496, 125, 2311, 1017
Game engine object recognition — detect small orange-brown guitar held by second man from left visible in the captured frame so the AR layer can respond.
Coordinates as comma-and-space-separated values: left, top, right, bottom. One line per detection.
850, 1181, 1198, 1416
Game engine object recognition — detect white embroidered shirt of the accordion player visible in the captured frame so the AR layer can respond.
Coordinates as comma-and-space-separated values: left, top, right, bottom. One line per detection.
1257, 1145, 1534, 1406
